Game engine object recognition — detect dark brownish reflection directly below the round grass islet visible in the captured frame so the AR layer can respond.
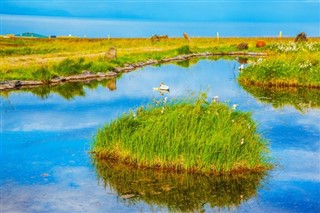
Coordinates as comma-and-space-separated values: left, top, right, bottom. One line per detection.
93, 159, 266, 212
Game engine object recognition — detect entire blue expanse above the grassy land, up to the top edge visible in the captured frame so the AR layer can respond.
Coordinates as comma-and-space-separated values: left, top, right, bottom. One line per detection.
0, 0, 320, 37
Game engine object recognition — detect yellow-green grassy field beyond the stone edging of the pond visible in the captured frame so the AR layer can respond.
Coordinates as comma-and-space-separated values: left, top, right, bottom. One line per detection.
0, 35, 319, 81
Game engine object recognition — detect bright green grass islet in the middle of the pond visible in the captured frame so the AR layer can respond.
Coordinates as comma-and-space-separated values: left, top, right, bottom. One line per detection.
92, 94, 270, 173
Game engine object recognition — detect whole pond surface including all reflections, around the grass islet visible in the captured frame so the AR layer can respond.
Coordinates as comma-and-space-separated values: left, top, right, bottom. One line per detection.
0, 59, 320, 212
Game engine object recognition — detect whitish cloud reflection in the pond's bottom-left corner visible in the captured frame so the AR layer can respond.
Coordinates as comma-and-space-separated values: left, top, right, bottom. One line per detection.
0, 166, 159, 212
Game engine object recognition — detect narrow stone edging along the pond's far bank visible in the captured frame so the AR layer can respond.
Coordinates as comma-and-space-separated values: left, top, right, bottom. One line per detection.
0, 52, 268, 91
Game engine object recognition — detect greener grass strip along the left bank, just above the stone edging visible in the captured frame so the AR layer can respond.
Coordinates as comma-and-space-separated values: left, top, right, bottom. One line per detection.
0, 46, 208, 81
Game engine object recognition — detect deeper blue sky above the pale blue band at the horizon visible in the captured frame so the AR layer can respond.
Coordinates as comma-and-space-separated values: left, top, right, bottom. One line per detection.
1, 0, 320, 23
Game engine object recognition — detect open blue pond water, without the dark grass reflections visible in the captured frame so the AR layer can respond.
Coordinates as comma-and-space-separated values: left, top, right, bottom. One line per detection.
0, 60, 320, 212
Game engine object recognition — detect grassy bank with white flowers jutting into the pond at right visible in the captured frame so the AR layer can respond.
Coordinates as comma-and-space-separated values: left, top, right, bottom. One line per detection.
239, 42, 320, 88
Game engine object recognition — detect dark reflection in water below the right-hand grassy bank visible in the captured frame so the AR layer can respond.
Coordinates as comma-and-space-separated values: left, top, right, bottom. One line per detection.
241, 85, 320, 111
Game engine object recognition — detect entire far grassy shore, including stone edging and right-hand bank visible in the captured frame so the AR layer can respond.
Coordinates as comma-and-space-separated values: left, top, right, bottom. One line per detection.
0, 35, 320, 90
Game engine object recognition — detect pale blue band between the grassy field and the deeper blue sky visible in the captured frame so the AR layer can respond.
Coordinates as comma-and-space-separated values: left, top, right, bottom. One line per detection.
1, 15, 320, 38
